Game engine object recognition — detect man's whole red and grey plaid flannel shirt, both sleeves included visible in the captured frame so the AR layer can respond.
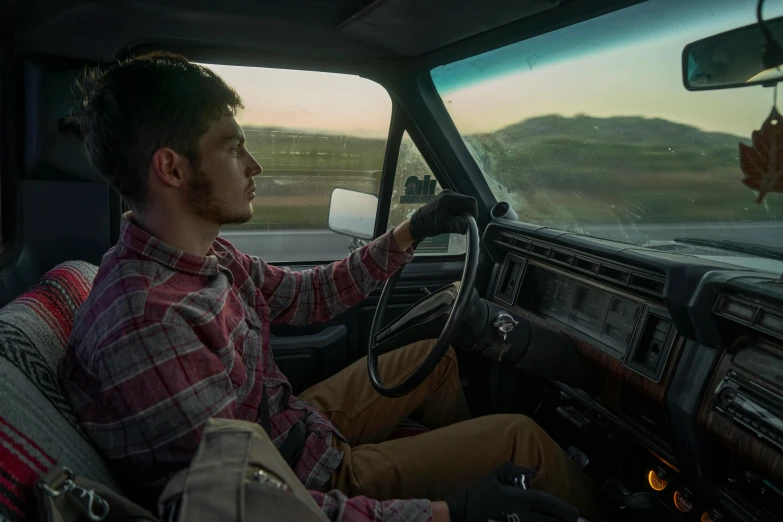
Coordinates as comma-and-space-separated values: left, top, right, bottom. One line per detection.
61, 215, 431, 522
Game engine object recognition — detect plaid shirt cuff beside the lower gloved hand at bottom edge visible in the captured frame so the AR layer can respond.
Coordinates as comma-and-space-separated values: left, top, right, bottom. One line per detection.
310, 490, 432, 522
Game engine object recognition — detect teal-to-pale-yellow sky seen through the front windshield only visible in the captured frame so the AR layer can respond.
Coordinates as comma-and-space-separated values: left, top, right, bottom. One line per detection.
433, 0, 783, 136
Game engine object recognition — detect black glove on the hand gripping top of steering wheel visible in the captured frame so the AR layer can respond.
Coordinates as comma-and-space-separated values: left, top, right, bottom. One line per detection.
411, 190, 478, 241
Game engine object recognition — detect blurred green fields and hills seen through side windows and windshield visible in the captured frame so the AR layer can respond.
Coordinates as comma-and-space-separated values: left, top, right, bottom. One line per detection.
228, 115, 783, 230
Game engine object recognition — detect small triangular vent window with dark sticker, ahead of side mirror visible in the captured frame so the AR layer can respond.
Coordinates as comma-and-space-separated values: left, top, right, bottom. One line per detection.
387, 131, 465, 256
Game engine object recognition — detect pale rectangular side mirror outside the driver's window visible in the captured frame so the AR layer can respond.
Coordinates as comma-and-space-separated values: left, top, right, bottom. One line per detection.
329, 188, 378, 239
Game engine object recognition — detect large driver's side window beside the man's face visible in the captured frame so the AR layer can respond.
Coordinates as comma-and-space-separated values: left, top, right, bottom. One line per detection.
205, 64, 392, 263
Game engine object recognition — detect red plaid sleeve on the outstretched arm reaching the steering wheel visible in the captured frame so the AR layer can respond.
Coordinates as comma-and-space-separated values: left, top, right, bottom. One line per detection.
239, 231, 413, 325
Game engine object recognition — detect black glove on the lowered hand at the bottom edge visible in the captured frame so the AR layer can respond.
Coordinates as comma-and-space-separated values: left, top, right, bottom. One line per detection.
446, 462, 578, 522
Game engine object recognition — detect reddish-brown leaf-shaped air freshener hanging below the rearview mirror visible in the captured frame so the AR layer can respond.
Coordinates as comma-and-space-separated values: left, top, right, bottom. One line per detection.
740, 107, 783, 203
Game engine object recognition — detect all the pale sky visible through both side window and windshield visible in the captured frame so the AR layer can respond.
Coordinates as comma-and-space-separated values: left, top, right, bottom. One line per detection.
201, 0, 783, 137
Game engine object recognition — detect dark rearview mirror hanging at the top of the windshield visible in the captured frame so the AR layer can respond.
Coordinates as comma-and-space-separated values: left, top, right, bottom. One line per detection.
682, 17, 783, 91
